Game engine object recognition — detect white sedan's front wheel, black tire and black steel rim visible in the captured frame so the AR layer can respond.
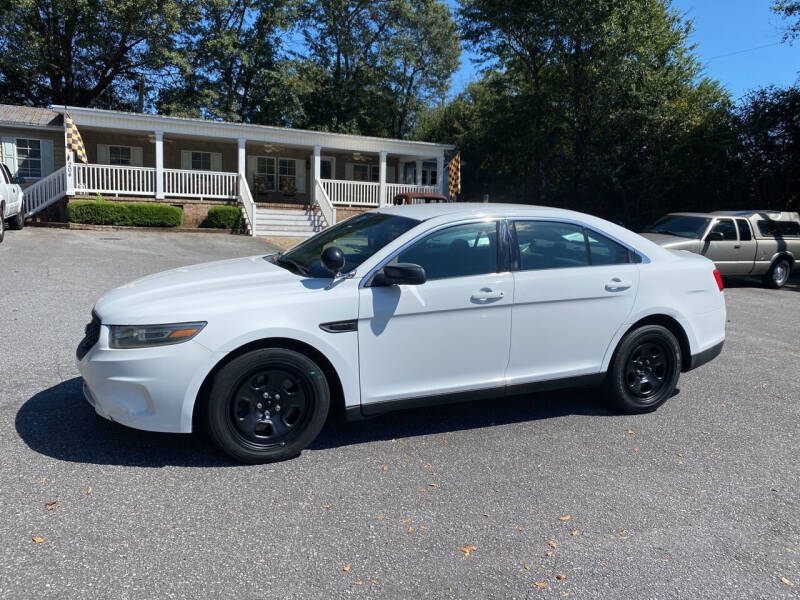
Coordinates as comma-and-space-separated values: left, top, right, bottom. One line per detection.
205, 348, 330, 464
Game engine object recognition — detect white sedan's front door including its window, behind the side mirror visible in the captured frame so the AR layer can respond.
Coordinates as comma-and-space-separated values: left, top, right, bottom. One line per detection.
358, 221, 514, 413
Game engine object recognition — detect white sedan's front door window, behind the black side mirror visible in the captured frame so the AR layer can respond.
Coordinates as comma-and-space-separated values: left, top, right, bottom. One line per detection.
396, 221, 497, 280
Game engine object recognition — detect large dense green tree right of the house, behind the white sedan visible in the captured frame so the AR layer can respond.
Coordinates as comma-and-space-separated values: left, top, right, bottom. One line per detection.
420, 0, 735, 224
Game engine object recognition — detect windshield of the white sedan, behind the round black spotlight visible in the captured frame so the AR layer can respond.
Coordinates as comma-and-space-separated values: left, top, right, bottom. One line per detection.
272, 212, 420, 277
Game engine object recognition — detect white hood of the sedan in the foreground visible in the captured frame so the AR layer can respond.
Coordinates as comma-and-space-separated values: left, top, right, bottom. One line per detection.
94, 256, 318, 325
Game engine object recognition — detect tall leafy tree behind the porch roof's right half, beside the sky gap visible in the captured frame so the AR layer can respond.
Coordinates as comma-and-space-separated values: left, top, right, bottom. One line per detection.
298, 0, 460, 137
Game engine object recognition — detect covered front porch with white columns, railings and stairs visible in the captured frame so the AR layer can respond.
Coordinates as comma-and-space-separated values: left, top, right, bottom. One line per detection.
21, 108, 448, 234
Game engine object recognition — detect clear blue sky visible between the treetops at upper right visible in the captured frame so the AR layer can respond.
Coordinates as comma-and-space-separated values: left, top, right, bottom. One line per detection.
449, 0, 800, 100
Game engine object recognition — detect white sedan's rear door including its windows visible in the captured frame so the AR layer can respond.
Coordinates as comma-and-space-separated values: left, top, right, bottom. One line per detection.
506, 220, 639, 386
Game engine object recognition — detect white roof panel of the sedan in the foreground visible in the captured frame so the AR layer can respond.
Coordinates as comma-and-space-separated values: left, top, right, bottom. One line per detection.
373, 202, 587, 221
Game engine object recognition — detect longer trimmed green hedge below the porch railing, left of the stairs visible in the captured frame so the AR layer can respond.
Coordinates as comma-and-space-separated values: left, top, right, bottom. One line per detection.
67, 200, 183, 227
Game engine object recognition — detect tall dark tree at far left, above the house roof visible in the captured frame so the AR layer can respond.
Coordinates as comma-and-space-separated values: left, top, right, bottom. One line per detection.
0, 0, 181, 109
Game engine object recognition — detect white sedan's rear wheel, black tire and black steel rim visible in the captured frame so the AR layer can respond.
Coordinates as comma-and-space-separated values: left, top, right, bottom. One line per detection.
606, 325, 681, 414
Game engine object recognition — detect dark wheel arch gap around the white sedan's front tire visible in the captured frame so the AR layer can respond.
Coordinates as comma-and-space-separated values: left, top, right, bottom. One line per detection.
192, 337, 345, 431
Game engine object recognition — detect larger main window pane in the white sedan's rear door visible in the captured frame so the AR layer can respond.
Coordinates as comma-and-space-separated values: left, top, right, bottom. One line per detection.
514, 221, 589, 271
